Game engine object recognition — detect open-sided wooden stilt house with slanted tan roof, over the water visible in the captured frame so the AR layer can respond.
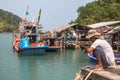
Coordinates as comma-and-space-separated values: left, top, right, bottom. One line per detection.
54, 23, 91, 49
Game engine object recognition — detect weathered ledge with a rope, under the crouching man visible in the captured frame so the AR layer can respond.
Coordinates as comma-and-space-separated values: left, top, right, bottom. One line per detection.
75, 65, 120, 80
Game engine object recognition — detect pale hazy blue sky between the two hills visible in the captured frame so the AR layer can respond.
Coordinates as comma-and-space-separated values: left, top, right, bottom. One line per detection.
0, 0, 93, 31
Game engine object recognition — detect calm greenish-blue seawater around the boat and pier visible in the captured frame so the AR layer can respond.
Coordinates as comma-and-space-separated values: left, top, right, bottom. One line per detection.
0, 33, 94, 80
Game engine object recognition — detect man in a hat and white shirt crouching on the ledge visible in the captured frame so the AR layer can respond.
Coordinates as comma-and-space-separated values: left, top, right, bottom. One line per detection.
84, 29, 115, 69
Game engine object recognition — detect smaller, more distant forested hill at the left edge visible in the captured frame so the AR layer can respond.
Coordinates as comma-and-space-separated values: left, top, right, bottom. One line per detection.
0, 9, 21, 32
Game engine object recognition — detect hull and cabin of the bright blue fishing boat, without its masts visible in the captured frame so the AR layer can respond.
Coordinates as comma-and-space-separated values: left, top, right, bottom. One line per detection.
13, 22, 48, 54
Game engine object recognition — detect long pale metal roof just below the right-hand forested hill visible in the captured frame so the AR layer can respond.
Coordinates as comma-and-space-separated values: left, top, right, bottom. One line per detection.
87, 21, 120, 28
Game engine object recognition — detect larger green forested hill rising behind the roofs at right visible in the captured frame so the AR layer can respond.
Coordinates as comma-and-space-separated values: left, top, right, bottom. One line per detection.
71, 0, 120, 25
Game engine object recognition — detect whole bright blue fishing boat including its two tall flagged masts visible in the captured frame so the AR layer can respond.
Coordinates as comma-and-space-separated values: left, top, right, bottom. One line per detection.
12, 7, 48, 54
